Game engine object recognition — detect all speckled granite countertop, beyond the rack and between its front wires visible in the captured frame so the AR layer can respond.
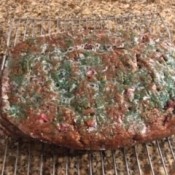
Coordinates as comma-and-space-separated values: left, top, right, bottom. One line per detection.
0, 0, 175, 175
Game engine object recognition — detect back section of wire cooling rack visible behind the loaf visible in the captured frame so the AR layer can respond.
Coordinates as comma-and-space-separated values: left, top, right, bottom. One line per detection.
1, 13, 172, 71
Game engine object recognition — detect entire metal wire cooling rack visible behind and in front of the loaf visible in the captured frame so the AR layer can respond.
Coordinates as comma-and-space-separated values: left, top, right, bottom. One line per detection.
0, 14, 175, 175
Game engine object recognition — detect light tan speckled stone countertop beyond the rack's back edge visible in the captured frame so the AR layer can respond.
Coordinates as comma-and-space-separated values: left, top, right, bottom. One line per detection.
0, 0, 175, 53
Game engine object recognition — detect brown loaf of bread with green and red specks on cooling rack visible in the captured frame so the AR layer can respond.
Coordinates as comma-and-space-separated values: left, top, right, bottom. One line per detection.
1, 31, 175, 150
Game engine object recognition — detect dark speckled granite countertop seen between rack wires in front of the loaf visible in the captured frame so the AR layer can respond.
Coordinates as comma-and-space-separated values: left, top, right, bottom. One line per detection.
0, 139, 175, 175
